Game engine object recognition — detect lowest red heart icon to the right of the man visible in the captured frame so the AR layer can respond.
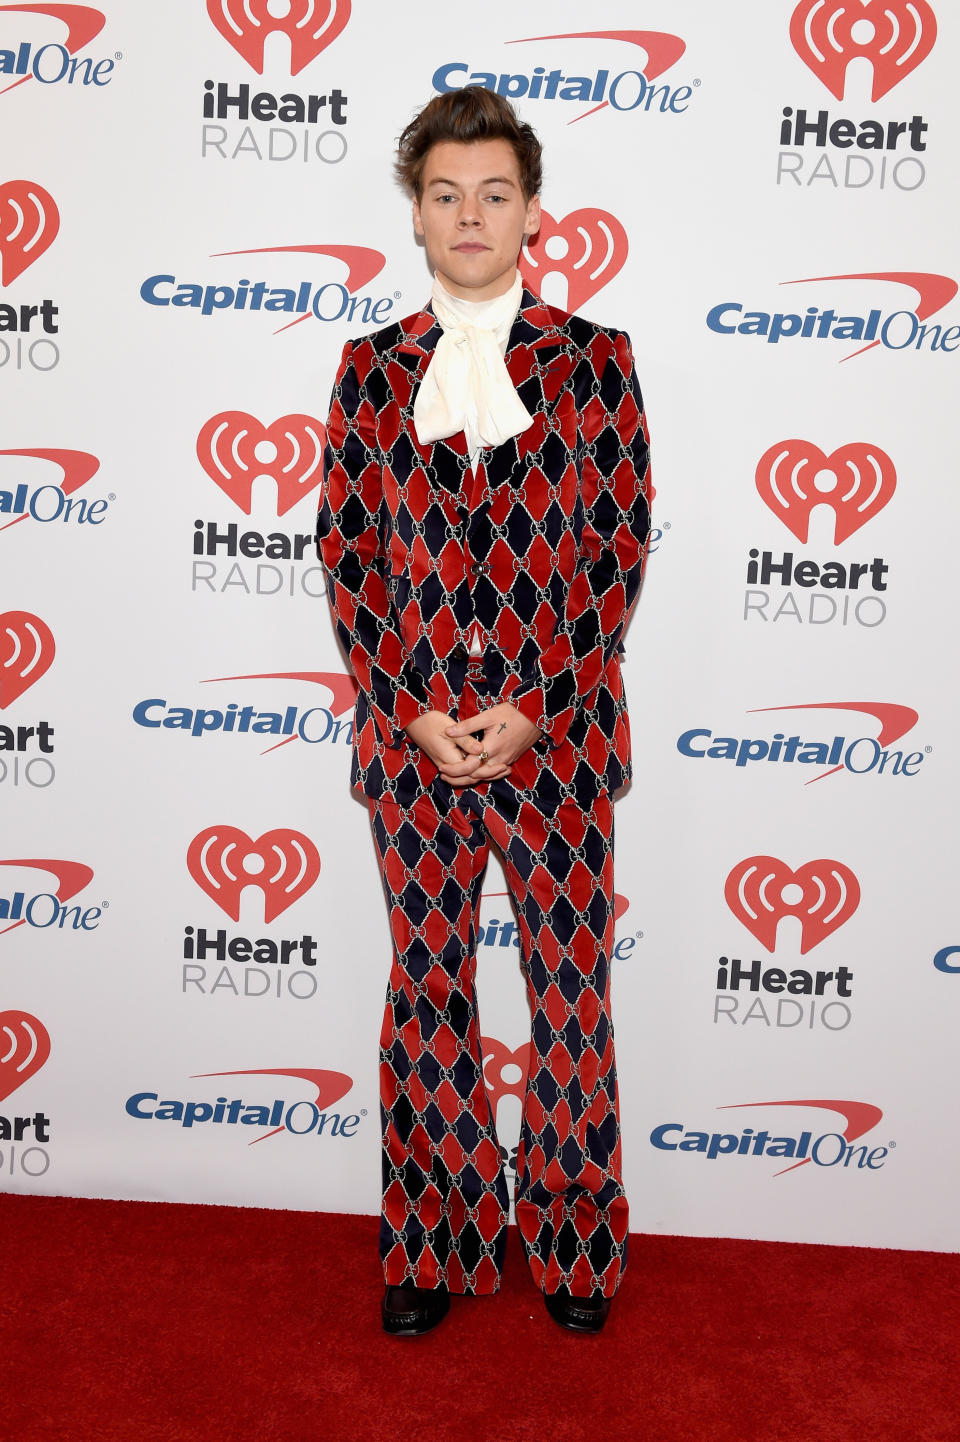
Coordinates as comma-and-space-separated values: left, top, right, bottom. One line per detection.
724, 857, 861, 956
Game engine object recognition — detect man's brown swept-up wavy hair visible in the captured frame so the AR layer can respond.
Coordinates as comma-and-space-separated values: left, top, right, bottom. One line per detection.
395, 85, 543, 200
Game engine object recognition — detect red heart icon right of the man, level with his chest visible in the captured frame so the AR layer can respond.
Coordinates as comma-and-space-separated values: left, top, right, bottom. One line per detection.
757, 438, 897, 545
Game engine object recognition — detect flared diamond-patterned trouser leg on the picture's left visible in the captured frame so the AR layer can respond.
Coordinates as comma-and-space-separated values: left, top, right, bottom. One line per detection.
364, 793, 509, 1295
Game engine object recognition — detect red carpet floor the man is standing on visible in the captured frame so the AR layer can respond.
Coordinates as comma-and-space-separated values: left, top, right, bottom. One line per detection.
0, 1194, 960, 1442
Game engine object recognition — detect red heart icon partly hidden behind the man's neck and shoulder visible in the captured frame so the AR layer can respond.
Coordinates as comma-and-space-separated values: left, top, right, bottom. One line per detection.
517, 209, 630, 310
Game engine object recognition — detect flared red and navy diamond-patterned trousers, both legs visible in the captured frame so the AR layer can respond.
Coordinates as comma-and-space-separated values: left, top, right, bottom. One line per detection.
369, 779, 627, 1296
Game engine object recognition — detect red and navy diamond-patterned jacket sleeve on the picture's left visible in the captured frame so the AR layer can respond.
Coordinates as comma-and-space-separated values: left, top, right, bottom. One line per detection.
317, 342, 434, 747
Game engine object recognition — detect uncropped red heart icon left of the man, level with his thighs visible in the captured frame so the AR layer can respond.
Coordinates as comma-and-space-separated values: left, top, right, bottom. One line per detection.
187, 826, 320, 923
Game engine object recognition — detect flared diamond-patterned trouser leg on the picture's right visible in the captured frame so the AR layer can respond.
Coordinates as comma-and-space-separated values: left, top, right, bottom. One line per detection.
483, 784, 627, 1296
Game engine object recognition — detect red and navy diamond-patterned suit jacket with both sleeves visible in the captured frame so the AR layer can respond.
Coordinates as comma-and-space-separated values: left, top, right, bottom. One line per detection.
317, 290, 649, 812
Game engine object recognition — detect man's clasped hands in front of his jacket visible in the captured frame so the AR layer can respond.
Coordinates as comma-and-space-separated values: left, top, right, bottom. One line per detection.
405, 701, 541, 786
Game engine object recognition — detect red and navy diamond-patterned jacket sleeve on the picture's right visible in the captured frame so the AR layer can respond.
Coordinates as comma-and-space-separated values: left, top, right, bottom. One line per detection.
503, 333, 650, 746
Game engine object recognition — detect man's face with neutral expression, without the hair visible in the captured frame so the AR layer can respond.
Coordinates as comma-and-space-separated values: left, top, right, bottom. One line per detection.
414, 140, 541, 300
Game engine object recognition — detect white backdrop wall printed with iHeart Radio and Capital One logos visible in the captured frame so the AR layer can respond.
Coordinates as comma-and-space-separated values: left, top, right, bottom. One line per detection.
0, 0, 960, 1249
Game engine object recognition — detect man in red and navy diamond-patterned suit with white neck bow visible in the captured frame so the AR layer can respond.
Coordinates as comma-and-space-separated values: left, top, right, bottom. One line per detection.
319, 87, 649, 1335
